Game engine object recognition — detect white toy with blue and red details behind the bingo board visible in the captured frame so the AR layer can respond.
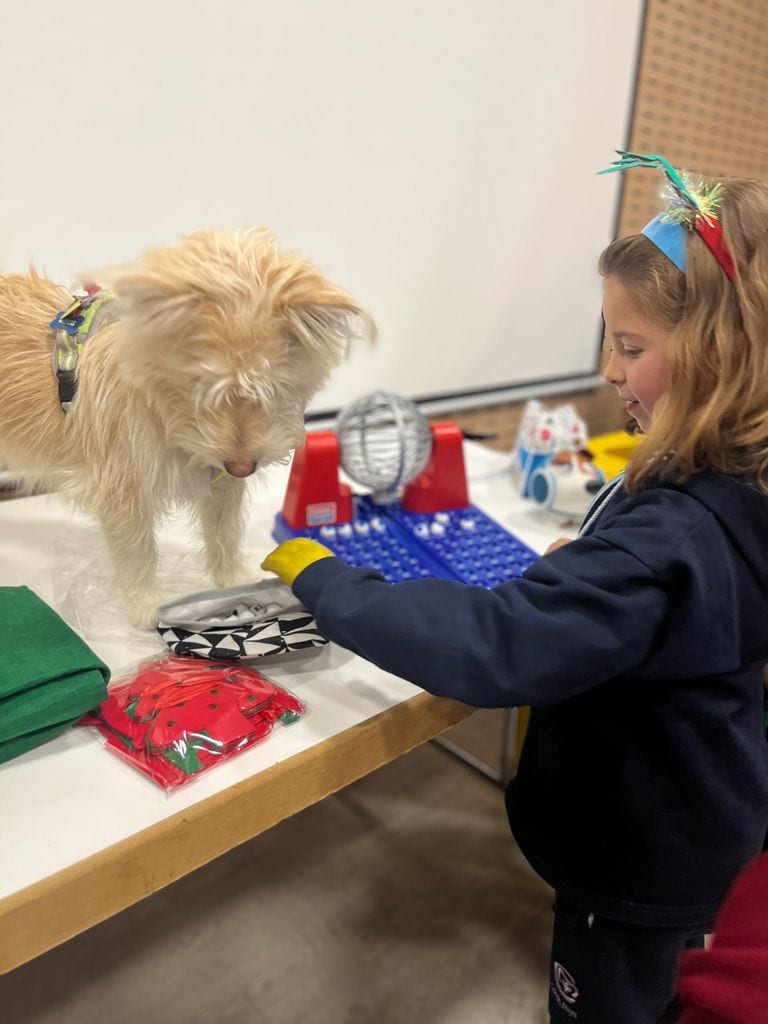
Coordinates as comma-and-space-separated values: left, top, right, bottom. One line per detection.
514, 399, 604, 524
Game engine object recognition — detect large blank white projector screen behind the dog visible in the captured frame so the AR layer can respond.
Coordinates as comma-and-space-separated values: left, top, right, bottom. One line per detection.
0, 0, 642, 413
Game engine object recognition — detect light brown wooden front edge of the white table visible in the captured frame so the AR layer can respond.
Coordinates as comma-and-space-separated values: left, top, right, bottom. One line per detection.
0, 693, 473, 974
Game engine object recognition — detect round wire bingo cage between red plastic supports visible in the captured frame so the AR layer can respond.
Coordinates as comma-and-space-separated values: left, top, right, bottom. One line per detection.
336, 391, 432, 505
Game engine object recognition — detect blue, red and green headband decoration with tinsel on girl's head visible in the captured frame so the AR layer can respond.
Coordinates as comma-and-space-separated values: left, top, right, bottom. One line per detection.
598, 150, 736, 281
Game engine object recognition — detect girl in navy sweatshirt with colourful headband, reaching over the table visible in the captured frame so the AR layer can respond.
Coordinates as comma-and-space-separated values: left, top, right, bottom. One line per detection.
263, 154, 768, 1024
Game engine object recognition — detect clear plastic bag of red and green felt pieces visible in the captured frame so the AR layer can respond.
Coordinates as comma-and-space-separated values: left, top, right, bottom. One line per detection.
79, 654, 305, 791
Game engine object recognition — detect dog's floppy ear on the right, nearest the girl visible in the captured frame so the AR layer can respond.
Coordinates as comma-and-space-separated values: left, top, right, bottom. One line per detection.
285, 292, 377, 367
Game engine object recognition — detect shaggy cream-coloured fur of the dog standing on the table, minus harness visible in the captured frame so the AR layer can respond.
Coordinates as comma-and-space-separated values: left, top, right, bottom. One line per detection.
0, 228, 374, 627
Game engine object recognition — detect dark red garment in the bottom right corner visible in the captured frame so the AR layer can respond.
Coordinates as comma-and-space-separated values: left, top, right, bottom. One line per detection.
680, 854, 768, 1024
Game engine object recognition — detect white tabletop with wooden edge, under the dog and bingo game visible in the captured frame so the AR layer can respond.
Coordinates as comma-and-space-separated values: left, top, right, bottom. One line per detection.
0, 443, 567, 973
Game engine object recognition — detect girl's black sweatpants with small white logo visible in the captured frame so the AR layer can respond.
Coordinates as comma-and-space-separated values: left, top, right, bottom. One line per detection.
549, 896, 708, 1024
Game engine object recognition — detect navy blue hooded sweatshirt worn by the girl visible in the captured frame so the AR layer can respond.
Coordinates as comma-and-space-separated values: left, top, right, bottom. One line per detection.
294, 472, 768, 927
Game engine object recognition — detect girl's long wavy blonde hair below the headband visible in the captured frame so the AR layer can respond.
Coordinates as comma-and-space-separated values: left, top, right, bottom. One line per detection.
599, 180, 768, 494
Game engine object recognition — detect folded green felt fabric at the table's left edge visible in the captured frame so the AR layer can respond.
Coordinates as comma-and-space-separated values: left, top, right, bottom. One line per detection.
0, 587, 110, 762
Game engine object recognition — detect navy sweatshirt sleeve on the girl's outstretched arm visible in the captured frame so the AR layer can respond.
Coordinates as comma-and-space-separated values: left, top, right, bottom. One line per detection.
294, 496, 727, 708
